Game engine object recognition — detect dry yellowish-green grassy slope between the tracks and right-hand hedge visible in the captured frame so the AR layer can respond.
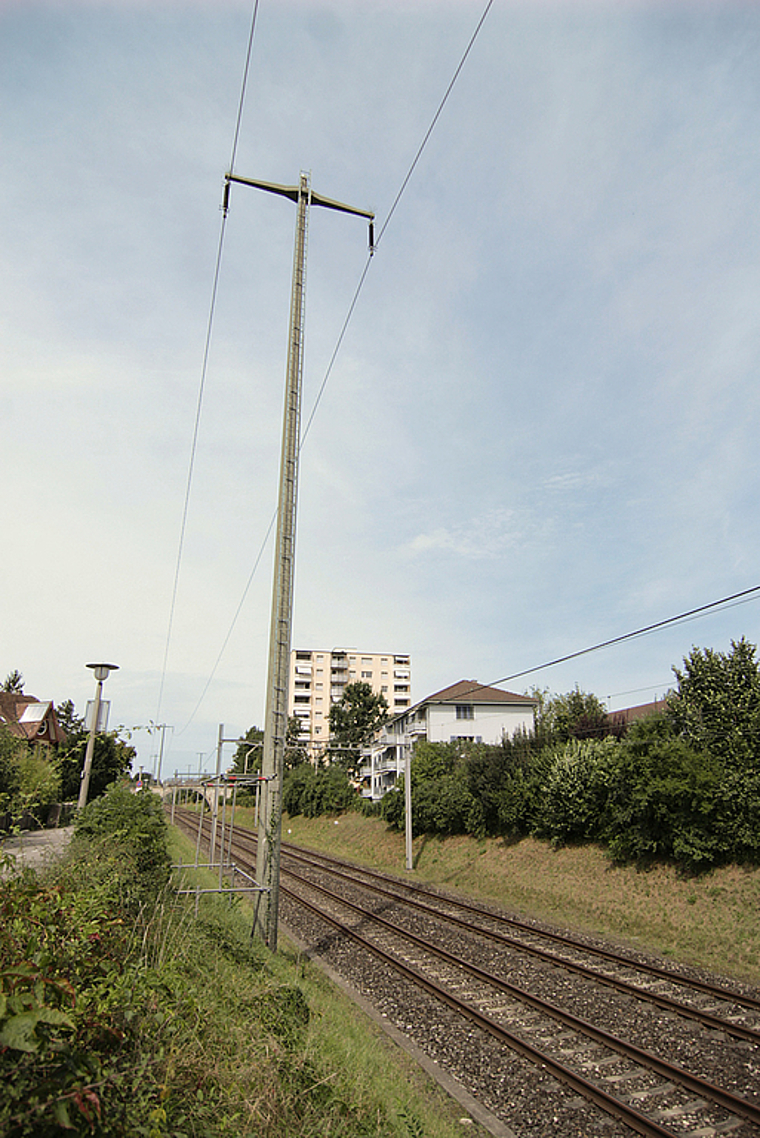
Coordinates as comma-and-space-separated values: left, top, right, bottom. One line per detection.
257, 811, 760, 984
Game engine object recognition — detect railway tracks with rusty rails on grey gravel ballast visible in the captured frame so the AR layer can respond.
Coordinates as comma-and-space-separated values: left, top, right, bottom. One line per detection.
170, 810, 760, 1138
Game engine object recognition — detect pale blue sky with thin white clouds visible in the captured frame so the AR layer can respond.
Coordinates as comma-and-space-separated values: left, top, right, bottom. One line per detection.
0, 0, 760, 772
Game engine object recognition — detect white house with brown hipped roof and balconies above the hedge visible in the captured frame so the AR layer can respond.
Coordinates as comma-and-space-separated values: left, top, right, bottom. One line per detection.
361, 679, 537, 800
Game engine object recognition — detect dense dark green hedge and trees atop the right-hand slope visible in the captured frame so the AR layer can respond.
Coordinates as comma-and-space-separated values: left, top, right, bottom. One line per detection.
375, 640, 760, 872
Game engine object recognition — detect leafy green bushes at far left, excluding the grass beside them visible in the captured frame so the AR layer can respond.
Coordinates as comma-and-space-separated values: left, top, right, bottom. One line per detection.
0, 787, 176, 1138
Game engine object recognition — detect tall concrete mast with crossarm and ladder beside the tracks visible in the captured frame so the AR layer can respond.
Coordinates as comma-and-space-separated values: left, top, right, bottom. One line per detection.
223, 173, 374, 951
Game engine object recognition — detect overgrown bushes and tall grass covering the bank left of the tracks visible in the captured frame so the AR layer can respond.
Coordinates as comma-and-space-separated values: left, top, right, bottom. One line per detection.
0, 786, 475, 1138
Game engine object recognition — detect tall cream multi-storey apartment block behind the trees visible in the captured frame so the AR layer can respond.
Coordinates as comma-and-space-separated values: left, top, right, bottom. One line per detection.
288, 648, 412, 756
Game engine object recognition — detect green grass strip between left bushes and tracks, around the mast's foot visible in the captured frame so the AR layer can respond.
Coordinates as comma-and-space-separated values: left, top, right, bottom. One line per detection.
166, 831, 482, 1138
